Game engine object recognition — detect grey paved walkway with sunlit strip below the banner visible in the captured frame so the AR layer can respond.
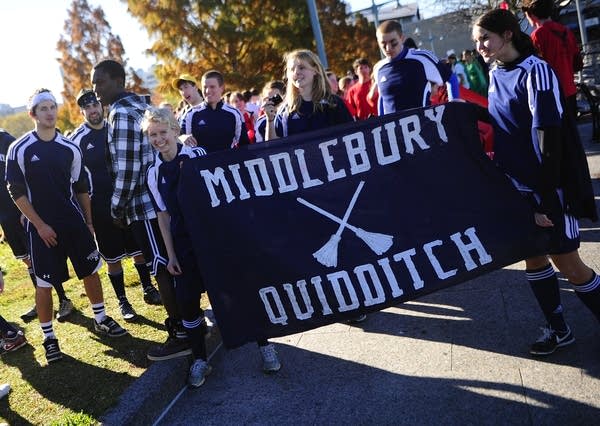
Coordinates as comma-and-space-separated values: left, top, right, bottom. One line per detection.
105, 124, 600, 425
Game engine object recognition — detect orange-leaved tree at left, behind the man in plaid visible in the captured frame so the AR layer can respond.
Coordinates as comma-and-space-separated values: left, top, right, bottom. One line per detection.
57, 0, 147, 131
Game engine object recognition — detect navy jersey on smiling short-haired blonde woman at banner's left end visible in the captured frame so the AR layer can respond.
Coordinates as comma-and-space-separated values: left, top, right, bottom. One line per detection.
148, 144, 206, 237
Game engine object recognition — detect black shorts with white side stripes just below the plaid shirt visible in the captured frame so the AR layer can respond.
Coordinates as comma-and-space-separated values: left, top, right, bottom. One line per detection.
127, 218, 168, 275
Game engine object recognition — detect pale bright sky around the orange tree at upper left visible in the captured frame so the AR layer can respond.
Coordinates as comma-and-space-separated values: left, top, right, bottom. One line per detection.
0, 0, 440, 107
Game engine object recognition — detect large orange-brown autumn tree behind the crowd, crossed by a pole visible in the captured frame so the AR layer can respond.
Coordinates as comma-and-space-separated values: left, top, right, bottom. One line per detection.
122, 0, 377, 93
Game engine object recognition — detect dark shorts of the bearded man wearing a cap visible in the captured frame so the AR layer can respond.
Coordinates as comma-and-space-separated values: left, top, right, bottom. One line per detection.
92, 200, 142, 263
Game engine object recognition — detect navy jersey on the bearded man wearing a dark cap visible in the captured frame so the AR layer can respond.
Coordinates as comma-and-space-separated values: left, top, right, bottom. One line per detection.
69, 122, 113, 203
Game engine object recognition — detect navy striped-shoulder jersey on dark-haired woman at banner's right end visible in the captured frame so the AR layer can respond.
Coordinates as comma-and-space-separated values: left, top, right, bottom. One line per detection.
488, 55, 563, 192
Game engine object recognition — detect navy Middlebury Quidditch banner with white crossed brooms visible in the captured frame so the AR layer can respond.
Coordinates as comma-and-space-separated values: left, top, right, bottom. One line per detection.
178, 103, 546, 348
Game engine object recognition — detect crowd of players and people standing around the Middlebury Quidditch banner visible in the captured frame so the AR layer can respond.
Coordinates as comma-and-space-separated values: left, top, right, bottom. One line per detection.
0, 0, 600, 396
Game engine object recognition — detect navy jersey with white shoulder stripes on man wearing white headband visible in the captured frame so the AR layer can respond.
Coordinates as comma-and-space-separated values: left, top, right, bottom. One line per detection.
6, 131, 84, 226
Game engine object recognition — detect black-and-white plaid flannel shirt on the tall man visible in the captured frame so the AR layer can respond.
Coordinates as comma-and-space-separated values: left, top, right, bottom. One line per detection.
108, 93, 156, 224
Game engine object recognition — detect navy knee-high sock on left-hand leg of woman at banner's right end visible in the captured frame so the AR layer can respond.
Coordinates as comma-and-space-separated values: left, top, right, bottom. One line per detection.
525, 264, 569, 332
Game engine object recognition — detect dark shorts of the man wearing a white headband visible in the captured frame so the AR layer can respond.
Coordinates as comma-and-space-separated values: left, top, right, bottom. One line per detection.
29, 220, 102, 287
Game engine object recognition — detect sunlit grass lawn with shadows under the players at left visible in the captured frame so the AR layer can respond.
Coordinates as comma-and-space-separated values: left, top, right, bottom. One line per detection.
0, 238, 197, 425
